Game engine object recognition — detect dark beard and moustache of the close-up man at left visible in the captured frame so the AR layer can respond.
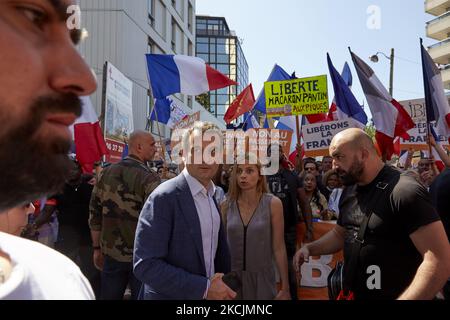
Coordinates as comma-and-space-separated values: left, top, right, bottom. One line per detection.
0, 94, 81, 212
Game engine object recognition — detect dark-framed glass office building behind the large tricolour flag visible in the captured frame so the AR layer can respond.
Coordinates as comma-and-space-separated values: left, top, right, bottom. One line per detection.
196, 16, 249, 119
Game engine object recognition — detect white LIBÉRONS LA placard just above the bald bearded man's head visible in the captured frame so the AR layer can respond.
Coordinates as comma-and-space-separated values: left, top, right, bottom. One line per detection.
302, 119, 355, 157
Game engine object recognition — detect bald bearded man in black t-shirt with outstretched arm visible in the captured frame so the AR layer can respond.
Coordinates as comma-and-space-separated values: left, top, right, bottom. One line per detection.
294, 129, 450, 300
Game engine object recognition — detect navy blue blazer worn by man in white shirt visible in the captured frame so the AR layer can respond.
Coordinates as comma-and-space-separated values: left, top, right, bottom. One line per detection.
133, 174, 231, 300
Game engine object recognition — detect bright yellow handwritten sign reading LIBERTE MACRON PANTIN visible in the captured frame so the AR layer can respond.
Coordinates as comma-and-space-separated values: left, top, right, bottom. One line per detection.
264, 75, 329, 118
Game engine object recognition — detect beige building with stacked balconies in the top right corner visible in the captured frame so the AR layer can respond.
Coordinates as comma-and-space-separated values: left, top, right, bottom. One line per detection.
425, 0, 450, 90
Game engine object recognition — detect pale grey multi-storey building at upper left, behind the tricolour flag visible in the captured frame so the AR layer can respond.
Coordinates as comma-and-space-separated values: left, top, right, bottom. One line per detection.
79, 0, 225, 142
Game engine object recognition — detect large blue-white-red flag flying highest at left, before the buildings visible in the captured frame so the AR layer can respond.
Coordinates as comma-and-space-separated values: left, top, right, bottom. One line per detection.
146, 54, 237, 99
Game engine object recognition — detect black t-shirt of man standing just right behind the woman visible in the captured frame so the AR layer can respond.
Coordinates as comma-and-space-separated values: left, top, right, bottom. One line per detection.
267, 169, 303, 230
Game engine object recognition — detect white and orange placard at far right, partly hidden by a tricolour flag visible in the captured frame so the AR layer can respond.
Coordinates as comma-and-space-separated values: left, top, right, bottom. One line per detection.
400, 99, 449, 151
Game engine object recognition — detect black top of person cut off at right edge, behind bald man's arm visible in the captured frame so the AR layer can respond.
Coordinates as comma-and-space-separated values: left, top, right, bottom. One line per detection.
430, 168, 450, 241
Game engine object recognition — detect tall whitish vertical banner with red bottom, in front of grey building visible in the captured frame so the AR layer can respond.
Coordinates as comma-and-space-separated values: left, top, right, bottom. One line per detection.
103, 62, 134, 163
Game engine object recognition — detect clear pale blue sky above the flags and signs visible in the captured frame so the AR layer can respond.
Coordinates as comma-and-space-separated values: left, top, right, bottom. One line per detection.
196, 0, 436, 117
